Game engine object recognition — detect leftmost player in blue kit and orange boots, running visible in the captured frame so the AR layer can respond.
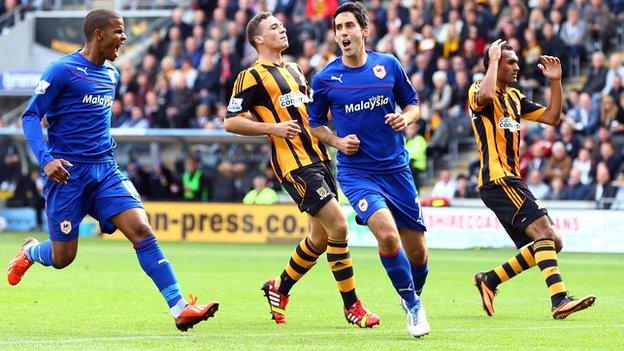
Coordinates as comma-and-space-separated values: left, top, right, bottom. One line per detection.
7, 10, 219, 331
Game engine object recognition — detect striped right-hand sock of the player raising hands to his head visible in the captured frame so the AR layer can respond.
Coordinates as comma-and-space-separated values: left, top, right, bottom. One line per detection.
533, 239, 567, 307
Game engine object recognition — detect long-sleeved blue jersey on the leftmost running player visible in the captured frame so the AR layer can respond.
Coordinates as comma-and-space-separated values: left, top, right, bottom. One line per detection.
22, 51, 119, 167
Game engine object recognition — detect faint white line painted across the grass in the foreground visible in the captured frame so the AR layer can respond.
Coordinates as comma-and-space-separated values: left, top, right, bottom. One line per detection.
0, 322, 624, 345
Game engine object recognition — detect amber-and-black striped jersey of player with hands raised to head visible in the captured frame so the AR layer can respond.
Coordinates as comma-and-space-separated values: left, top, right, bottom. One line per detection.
468, 81, 546, 187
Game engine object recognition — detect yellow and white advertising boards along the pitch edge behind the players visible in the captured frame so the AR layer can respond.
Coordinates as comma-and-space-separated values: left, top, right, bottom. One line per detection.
92, 202, 624, 253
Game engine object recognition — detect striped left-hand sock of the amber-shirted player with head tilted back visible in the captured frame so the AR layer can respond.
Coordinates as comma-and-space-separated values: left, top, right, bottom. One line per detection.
277, 237, 323, 295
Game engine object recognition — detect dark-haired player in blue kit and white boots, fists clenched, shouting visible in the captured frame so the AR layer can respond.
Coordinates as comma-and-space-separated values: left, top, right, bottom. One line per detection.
308, 2, 430, 337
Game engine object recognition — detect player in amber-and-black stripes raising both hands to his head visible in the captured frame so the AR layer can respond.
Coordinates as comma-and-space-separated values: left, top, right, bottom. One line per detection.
468, 39, 596, 319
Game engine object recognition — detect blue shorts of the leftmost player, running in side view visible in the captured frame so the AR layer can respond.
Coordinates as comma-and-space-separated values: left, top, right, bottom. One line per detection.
44, 161, 143, 241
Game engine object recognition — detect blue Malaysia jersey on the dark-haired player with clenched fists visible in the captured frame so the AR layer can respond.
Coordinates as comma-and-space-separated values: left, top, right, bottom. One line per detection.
308, 51, 418, 173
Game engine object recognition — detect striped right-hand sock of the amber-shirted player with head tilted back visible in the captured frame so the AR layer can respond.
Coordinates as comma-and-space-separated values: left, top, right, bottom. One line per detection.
327, 240, 357, 308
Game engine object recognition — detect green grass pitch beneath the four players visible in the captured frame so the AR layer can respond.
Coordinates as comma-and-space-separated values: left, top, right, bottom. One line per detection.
0, 233, 624, 351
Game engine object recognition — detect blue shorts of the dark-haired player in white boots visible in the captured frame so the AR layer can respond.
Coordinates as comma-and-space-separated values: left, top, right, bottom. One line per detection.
338, 167, 427, 232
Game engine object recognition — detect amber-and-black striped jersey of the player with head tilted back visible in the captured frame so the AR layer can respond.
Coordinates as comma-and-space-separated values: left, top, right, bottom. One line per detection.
226, 60, 331, 180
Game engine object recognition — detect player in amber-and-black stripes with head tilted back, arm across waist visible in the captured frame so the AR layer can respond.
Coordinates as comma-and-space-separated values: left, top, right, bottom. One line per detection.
224, 12, 379, 328
